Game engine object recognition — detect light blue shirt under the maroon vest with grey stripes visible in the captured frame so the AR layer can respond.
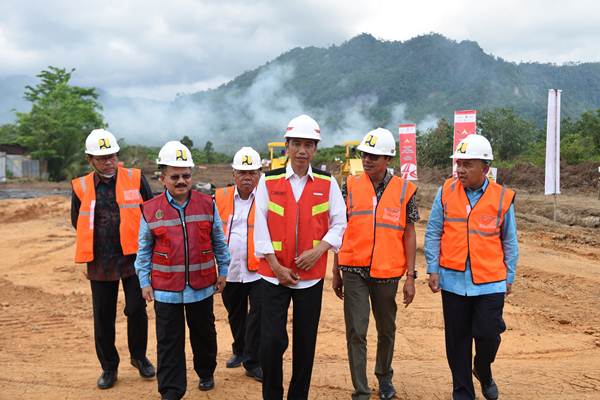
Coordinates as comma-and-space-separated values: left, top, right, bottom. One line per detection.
135, 191, 231, 304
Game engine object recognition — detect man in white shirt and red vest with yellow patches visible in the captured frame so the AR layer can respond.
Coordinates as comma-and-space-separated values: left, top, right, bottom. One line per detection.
254, 115, 346, 400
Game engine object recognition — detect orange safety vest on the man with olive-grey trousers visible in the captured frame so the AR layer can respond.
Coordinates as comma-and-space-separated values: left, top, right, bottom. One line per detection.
338, 174, 417, 279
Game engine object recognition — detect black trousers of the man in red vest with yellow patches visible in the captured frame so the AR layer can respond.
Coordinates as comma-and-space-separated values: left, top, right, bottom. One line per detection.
260, 280, 323, 400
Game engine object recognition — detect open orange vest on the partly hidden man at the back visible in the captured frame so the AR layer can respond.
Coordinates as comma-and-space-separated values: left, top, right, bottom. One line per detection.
215, 186, 259, 271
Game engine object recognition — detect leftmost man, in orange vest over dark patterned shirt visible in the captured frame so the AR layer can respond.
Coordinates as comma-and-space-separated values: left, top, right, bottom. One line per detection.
71, 129, 155, 389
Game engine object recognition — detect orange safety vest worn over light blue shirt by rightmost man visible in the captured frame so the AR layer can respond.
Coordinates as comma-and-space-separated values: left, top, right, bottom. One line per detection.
440, 179, 515, 284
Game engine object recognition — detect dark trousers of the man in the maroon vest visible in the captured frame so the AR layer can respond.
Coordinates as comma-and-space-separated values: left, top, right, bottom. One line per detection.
154, 296, 217, 399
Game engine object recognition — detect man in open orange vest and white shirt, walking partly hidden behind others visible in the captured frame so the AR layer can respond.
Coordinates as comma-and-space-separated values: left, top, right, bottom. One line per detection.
215, 147, 262, 381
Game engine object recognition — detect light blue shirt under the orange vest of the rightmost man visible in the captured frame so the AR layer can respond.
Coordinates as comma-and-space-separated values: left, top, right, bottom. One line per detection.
425, 179, 519, 296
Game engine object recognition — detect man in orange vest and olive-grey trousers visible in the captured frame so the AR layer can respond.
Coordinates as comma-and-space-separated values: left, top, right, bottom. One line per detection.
332, 128, 419, 399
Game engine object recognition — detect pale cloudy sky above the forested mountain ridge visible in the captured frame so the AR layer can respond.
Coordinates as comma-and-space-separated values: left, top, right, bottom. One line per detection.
0, 0, 600, 100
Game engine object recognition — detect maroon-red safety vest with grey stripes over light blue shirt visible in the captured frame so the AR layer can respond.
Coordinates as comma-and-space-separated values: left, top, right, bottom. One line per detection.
142, 190, 217, 292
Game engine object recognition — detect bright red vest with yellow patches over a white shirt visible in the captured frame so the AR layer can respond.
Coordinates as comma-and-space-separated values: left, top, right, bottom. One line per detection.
258, 168, 331, 280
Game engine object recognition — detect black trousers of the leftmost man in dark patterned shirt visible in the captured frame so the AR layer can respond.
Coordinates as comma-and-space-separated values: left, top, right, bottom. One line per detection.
90, 275, 148, 371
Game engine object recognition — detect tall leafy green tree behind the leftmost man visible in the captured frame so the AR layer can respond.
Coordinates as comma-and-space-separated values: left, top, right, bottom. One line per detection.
17, 66, 106, 180
